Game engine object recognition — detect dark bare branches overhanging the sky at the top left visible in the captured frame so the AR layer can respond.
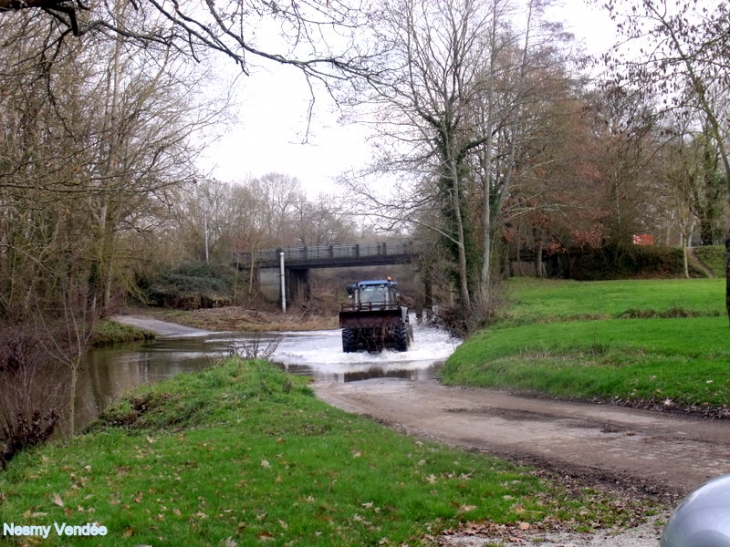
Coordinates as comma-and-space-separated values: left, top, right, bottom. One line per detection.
0, 0, 372, 84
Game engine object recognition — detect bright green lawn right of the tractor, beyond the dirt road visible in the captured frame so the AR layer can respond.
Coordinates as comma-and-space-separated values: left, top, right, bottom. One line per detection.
442, 279, 730, 414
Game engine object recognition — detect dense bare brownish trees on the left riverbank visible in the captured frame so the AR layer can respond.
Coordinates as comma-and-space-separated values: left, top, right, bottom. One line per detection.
0, 3, 236, 446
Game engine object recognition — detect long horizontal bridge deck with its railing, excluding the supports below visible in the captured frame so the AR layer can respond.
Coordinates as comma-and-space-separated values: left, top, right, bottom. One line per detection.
238, 239, 426, 269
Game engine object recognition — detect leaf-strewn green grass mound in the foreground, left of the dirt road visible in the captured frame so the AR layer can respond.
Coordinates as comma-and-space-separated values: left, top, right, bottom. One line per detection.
0, 358, 653, 547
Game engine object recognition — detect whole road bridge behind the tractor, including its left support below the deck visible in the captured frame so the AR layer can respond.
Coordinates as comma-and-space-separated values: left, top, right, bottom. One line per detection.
236, 238, 427, 308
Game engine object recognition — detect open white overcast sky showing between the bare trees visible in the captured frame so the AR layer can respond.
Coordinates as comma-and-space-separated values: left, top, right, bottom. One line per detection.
193, 0, 615, 197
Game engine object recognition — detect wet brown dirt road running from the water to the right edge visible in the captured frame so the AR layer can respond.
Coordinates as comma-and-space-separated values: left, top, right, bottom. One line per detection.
315, 379, 730, 495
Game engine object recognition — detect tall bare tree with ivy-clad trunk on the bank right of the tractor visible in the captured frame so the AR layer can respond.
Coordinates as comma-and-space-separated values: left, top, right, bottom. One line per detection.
342, 0, 576, 321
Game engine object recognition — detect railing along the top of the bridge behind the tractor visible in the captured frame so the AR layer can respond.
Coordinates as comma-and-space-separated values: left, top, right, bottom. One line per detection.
238, 239, 425, 266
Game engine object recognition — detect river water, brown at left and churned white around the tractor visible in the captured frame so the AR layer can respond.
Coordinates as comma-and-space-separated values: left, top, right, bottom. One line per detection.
76, 318, 460, 432
